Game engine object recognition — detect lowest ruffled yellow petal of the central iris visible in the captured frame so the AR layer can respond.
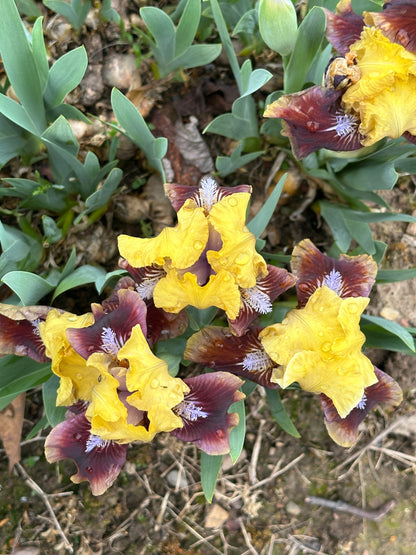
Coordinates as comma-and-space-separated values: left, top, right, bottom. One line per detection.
153, 270, 241, 320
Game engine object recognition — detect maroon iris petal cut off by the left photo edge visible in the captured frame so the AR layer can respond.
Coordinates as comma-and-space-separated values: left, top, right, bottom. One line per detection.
0, 303, 52, 362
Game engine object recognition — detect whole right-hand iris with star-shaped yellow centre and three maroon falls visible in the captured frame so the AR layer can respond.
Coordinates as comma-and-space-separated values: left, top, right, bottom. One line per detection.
185, 239, 402, 446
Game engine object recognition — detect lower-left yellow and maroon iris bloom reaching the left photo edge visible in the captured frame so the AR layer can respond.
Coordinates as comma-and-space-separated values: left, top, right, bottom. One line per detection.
0, 279, 243, 495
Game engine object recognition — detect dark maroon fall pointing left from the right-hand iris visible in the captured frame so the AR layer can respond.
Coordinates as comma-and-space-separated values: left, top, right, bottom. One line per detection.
184, 326, 278, 389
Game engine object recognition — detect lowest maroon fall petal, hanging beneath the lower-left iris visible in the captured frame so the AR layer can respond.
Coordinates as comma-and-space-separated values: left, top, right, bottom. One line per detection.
45, 413, 127, 495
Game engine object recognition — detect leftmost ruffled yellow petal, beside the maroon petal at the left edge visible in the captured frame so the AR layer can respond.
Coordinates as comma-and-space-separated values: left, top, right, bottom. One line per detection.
39, 310, 98, 406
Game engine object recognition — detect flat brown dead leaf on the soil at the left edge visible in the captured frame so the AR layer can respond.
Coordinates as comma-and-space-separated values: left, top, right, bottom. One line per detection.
0, 393, 26, 472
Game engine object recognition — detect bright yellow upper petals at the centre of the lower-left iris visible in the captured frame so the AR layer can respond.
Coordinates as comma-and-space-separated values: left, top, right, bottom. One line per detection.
86, 346, 185, 443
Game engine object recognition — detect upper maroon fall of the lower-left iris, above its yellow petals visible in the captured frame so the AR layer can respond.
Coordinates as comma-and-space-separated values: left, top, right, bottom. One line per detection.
66, 289, 147, 359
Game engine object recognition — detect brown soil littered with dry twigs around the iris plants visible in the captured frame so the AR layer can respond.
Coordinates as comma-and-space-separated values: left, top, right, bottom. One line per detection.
0, 0, 416, 555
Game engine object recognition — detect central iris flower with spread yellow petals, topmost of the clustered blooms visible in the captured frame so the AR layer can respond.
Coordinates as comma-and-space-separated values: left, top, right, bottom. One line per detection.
119, 177, 293, 334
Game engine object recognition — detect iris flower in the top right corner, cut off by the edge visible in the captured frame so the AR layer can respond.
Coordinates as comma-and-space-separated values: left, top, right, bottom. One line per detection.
264, 0, 416, 158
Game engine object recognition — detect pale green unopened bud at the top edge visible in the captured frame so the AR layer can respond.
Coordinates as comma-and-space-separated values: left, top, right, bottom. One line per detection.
259, 0, 298, 56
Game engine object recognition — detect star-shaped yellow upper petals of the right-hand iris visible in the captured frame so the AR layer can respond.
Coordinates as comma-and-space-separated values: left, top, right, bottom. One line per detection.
260, 286, 377, 418
